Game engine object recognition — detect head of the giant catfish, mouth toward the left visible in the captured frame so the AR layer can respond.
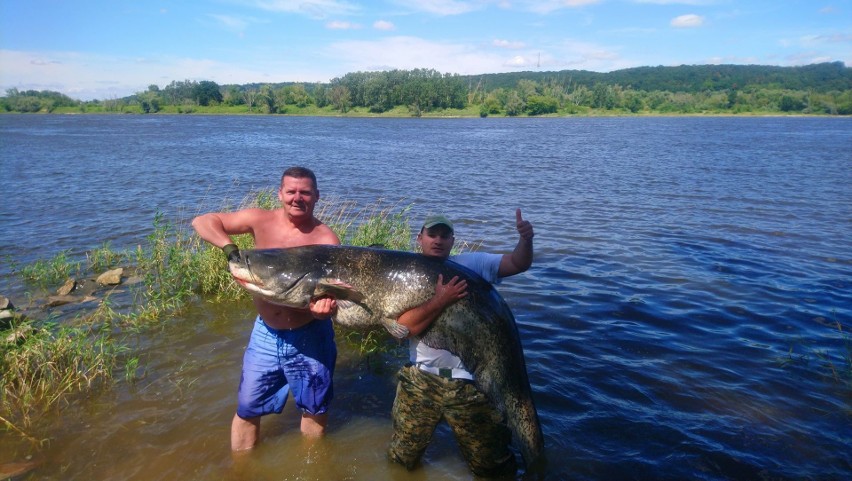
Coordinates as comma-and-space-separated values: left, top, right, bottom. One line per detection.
228, 249, 321, 309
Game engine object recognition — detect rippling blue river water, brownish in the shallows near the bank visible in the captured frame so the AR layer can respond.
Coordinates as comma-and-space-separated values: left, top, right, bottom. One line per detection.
0, 115, 852, 480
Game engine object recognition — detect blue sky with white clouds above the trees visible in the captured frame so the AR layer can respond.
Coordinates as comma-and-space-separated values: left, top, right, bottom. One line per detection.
0, 0, 852, 100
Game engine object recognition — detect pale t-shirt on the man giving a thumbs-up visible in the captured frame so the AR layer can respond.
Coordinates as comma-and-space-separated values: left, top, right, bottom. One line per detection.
408, 252, 503, 379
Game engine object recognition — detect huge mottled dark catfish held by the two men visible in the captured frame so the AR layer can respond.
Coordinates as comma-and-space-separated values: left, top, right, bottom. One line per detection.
230, 245, 544, 468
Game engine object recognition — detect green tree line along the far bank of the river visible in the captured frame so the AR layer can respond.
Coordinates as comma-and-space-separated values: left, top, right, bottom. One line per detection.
0, 62, 852, 117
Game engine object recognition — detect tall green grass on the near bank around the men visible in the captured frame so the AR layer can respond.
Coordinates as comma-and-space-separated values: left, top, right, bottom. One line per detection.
0, 190, 418, 443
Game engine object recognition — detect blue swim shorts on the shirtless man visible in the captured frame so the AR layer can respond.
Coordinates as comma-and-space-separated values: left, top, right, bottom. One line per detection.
237, 316, 337, 418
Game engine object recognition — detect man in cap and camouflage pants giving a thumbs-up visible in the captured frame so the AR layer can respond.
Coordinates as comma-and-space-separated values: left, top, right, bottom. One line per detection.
388, 209, 533, 478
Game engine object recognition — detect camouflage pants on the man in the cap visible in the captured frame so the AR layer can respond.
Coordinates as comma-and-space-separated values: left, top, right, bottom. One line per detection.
388, 366, 517, 477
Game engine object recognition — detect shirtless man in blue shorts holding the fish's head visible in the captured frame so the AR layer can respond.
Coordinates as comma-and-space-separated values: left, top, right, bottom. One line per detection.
192, 167, 340, 451
